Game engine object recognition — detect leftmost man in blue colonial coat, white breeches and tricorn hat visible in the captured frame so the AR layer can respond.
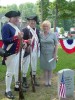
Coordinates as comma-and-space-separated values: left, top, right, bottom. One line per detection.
2, 11, 27, 99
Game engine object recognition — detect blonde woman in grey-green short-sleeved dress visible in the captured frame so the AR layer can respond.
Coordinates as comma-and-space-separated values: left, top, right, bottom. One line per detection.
40, 20, 58, 86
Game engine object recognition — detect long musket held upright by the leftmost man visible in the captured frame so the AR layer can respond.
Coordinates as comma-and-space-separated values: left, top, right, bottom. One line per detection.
18, 39, 25, 100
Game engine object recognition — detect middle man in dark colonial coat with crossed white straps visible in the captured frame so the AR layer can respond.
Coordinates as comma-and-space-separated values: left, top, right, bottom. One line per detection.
22, 16, 39, 88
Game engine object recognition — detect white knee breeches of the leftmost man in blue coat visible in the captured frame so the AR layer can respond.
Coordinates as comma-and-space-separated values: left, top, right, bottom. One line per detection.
5, 50, 24, 82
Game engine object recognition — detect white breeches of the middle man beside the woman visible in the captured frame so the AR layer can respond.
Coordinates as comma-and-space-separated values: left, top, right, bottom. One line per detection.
22, 51, 37, 77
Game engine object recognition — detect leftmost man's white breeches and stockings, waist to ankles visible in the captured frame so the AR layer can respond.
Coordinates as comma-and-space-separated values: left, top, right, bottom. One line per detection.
5, 50, 23, 92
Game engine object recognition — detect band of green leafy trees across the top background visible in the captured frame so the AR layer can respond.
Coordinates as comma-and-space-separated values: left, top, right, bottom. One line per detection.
0, 0, 75, 31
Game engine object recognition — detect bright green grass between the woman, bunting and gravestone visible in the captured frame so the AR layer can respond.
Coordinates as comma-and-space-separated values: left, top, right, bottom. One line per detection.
54, 48, 75, 72
